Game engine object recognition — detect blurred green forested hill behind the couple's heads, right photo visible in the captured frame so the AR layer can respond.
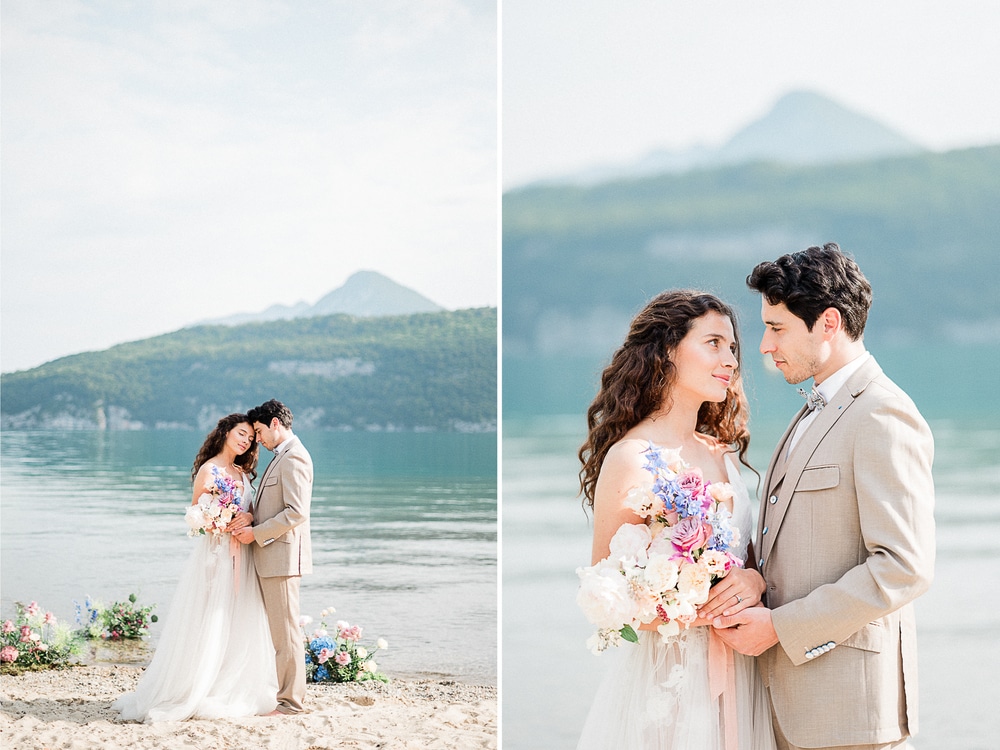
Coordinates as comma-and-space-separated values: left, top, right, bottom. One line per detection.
503, 146, 1000, 357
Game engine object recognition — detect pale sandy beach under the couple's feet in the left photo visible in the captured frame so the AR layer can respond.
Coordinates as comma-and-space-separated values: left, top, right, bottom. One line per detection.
0, 665, 498, 750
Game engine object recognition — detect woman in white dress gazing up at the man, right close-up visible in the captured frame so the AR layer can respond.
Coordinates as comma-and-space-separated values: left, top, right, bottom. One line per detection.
578, 291, 775, 750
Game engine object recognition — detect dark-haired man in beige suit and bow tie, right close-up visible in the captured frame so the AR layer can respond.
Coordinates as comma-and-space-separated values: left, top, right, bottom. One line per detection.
713, 243, 934, 750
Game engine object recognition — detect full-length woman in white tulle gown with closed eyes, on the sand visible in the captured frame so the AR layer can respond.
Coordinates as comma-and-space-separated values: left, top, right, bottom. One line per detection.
112, 414, 278, 722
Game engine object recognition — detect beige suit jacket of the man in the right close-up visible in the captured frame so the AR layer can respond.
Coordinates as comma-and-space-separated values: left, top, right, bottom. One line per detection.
754, 358, 934, 747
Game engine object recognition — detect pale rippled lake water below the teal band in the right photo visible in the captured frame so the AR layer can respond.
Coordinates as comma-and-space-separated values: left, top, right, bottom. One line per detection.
501, 414, 1000, 750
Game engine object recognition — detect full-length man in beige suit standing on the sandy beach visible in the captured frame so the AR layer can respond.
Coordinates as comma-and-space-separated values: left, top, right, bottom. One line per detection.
233, 399, 313, 714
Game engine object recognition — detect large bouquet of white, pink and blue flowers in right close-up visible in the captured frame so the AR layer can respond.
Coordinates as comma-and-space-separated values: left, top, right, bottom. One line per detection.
576, 443, 743, 654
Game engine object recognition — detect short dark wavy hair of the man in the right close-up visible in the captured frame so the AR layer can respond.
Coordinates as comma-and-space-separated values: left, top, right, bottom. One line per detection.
747, 242, 872, 341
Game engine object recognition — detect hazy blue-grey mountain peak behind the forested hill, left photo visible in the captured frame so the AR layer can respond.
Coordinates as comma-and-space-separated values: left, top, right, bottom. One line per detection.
197, 271, 444, 326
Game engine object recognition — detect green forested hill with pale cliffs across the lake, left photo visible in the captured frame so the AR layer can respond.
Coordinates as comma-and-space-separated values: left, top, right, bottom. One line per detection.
0, 308, 497, 430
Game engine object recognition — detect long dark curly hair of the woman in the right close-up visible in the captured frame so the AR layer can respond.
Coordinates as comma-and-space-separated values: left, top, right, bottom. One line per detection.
577, 289, 753, 508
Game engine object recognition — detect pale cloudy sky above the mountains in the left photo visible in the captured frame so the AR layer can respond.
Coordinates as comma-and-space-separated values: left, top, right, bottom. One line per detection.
0, 0, 498, 372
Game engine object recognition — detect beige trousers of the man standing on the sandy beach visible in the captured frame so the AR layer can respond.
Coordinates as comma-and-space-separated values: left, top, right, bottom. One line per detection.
258, 576, 306, 714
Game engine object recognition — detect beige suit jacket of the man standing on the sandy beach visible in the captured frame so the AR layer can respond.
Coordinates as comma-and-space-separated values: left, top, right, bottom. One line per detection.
253, 437, 313, 578
